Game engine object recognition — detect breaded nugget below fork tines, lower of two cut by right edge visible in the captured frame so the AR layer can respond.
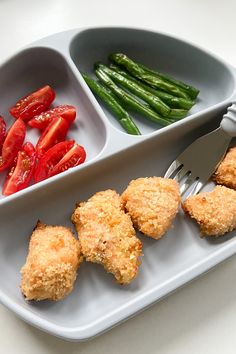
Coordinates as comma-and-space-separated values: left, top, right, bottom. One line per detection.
183, 186, 236, 237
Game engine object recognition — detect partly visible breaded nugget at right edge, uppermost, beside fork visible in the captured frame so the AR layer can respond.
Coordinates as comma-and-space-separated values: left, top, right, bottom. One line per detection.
213, 146, 236, 189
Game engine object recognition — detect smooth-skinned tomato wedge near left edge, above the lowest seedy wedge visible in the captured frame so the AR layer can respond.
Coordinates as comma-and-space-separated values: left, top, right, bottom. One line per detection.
0, 119, 26, 172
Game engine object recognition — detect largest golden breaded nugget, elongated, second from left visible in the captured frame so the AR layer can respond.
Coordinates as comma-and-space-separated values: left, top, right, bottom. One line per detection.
72, 190, 142, 284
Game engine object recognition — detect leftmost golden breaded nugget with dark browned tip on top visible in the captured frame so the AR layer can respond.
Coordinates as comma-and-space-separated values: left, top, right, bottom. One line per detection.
21, 222, 83, 300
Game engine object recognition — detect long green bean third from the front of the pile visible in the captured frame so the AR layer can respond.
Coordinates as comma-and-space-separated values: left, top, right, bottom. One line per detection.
95, 63, 170, 116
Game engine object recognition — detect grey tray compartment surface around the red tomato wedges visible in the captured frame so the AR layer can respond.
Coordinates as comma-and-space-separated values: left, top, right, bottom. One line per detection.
0, 47, 107, 198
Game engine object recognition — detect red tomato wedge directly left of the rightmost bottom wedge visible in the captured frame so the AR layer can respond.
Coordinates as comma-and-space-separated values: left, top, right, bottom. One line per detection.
34, 140, 75, 182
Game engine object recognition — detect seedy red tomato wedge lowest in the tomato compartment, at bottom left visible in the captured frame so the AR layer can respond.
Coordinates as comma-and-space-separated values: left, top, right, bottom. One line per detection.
2, 142, 36, 196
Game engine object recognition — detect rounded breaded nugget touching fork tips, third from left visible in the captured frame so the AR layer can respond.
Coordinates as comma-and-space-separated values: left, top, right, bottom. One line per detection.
121, 177, 180, 240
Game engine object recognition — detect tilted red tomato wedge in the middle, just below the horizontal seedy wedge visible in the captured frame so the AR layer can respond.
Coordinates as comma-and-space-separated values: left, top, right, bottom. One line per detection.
36, 117, 69, 158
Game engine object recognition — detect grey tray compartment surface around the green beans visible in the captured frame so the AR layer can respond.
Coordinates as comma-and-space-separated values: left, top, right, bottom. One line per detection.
70, 27, 235, 134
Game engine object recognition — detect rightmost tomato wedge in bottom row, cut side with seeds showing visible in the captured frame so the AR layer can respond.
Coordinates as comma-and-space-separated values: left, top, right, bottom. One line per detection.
50, 144, 86, 176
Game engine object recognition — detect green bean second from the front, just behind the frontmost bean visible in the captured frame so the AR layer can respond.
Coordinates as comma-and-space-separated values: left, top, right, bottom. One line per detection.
95, 69, 171, 126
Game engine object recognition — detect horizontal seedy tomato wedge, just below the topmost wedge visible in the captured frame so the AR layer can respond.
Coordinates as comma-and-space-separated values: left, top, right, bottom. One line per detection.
28, 105, 76, 130
